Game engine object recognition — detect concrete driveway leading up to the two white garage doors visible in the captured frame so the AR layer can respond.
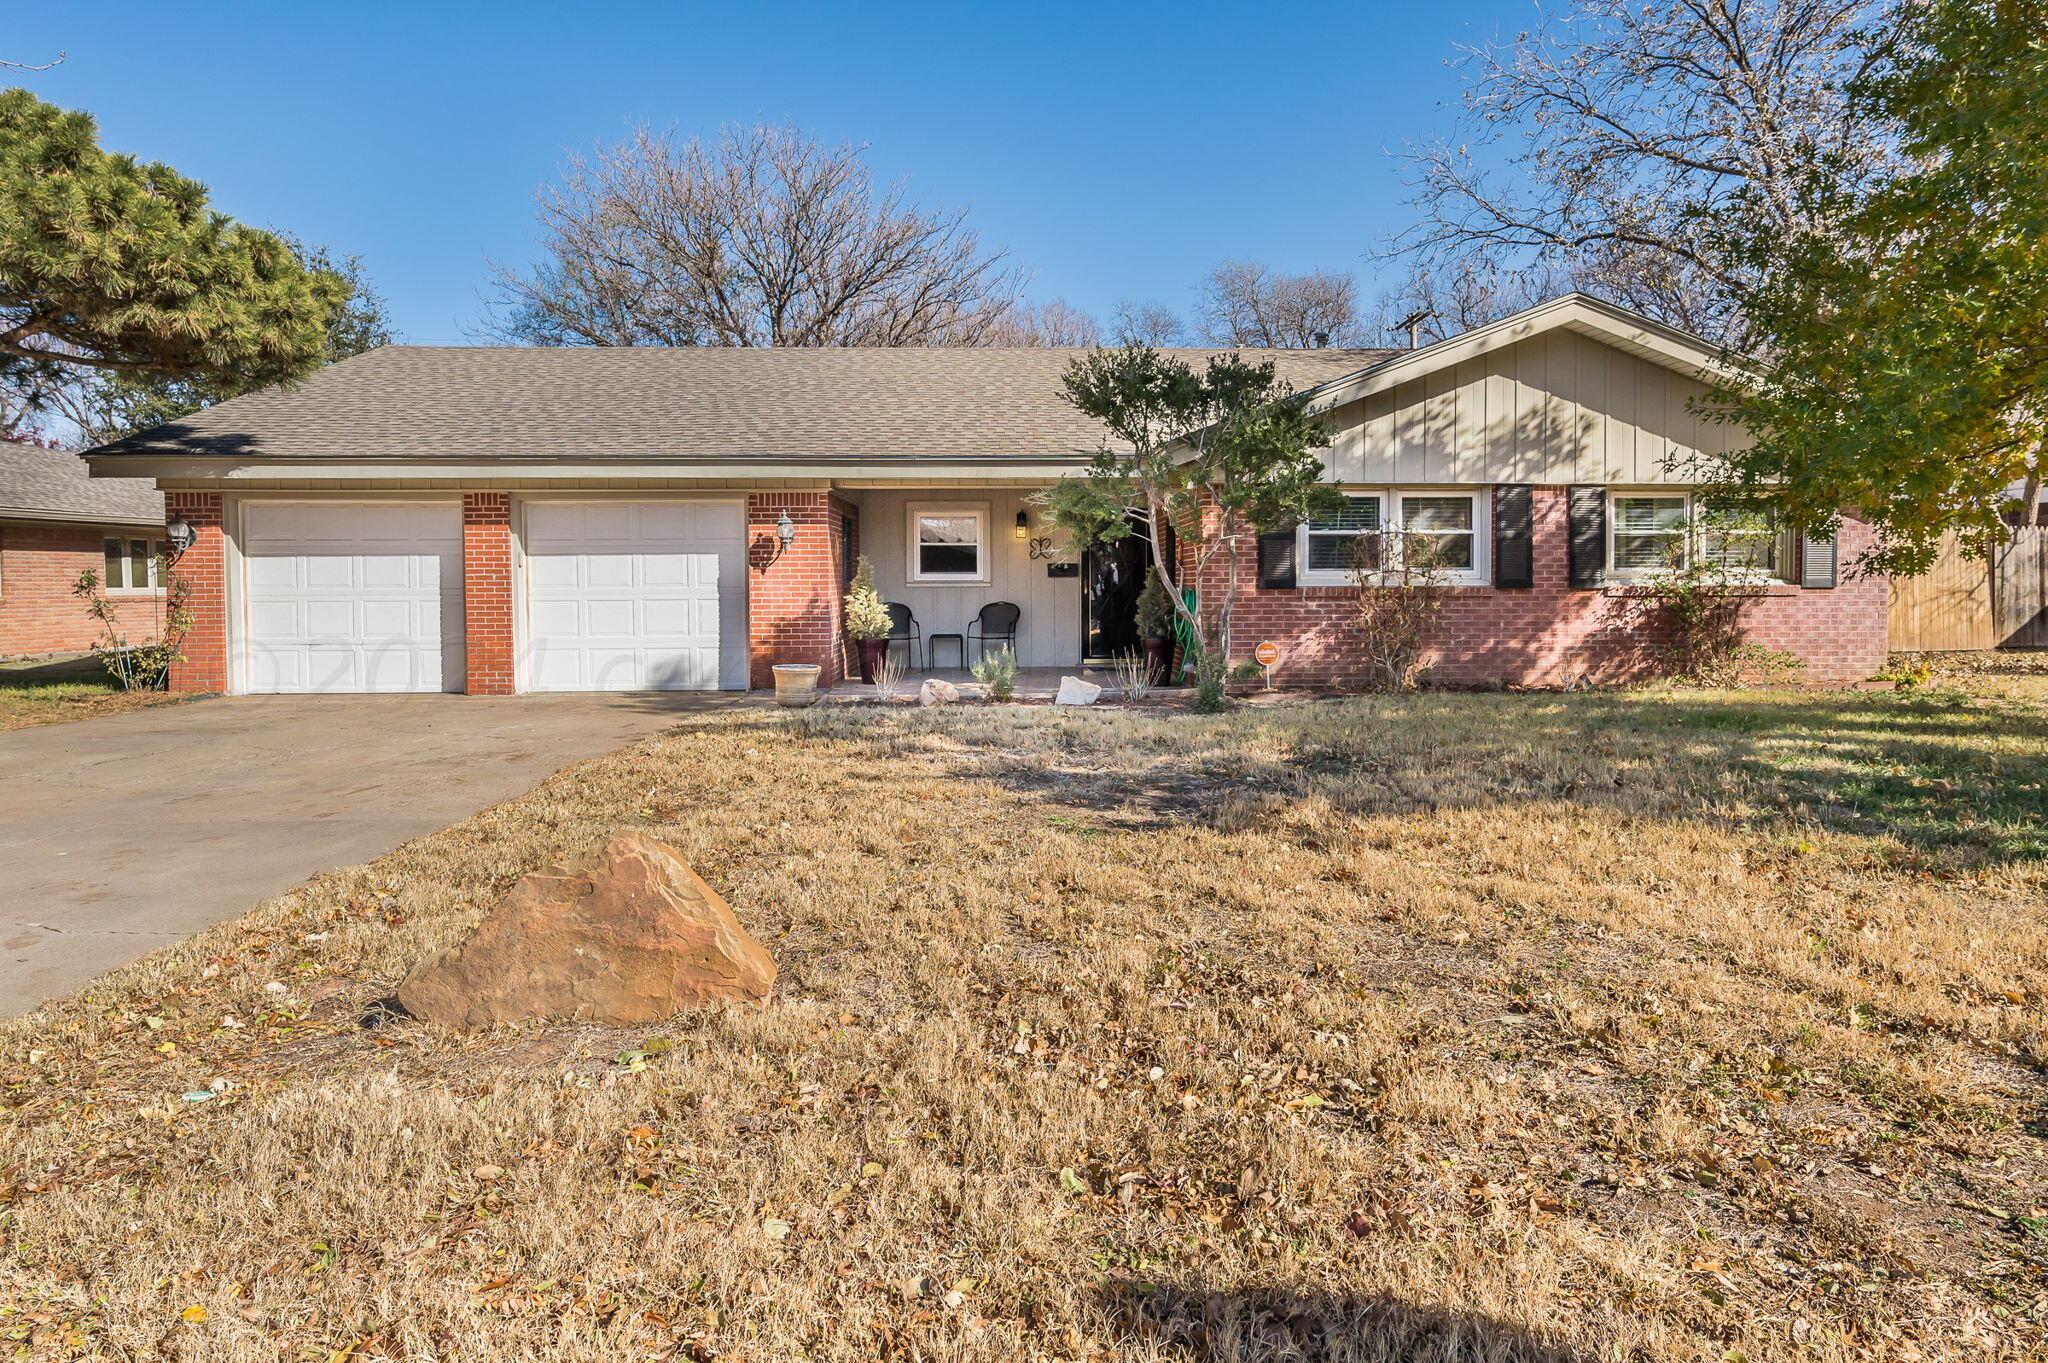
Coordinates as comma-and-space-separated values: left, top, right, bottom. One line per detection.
0, 694, 745, 1017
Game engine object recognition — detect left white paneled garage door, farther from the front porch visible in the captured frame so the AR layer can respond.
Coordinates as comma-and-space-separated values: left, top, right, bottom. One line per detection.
242, 501, 465, 692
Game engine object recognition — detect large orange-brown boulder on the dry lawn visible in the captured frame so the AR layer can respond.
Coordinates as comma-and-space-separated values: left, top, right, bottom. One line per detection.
397, 833, 774, 1027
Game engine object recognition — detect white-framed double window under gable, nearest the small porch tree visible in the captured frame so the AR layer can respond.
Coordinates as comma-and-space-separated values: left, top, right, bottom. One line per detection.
1296, 489, 1489, 587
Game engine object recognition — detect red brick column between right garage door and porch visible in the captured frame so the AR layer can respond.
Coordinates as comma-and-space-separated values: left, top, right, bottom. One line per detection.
748, 491, 846, 688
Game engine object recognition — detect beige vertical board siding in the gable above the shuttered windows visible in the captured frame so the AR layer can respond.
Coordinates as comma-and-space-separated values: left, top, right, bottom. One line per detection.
1325, 329, 1733, 485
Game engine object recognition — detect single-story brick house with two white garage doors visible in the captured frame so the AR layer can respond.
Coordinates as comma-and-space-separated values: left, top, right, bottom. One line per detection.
88, 295, 1886, 694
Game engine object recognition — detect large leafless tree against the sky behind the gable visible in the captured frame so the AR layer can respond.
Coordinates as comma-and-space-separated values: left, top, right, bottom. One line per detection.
1393, 0, 1907, 342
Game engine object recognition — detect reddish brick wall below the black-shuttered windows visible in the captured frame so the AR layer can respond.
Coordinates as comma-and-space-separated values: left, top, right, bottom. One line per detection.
1200, 487, 1888, 688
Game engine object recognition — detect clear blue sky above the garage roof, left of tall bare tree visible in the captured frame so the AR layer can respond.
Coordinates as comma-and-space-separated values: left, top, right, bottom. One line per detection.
12, 0, 1532, 342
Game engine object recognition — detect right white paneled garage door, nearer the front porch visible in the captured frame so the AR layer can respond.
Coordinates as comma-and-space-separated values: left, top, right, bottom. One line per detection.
522, 501, 748, 692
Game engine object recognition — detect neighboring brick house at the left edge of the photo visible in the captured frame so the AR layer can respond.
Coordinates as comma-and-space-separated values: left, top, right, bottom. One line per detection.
0, 442, 164, 657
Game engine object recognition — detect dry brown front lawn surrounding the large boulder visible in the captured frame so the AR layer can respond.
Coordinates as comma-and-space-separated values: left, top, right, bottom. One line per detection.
0, 677, 2048, 1363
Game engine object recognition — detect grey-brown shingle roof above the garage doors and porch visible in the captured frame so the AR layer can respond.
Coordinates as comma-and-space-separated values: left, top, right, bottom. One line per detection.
79, 346, 1401, 460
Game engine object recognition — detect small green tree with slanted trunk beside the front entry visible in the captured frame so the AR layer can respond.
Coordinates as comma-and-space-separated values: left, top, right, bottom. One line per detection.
1042, 344, 1339, 694
